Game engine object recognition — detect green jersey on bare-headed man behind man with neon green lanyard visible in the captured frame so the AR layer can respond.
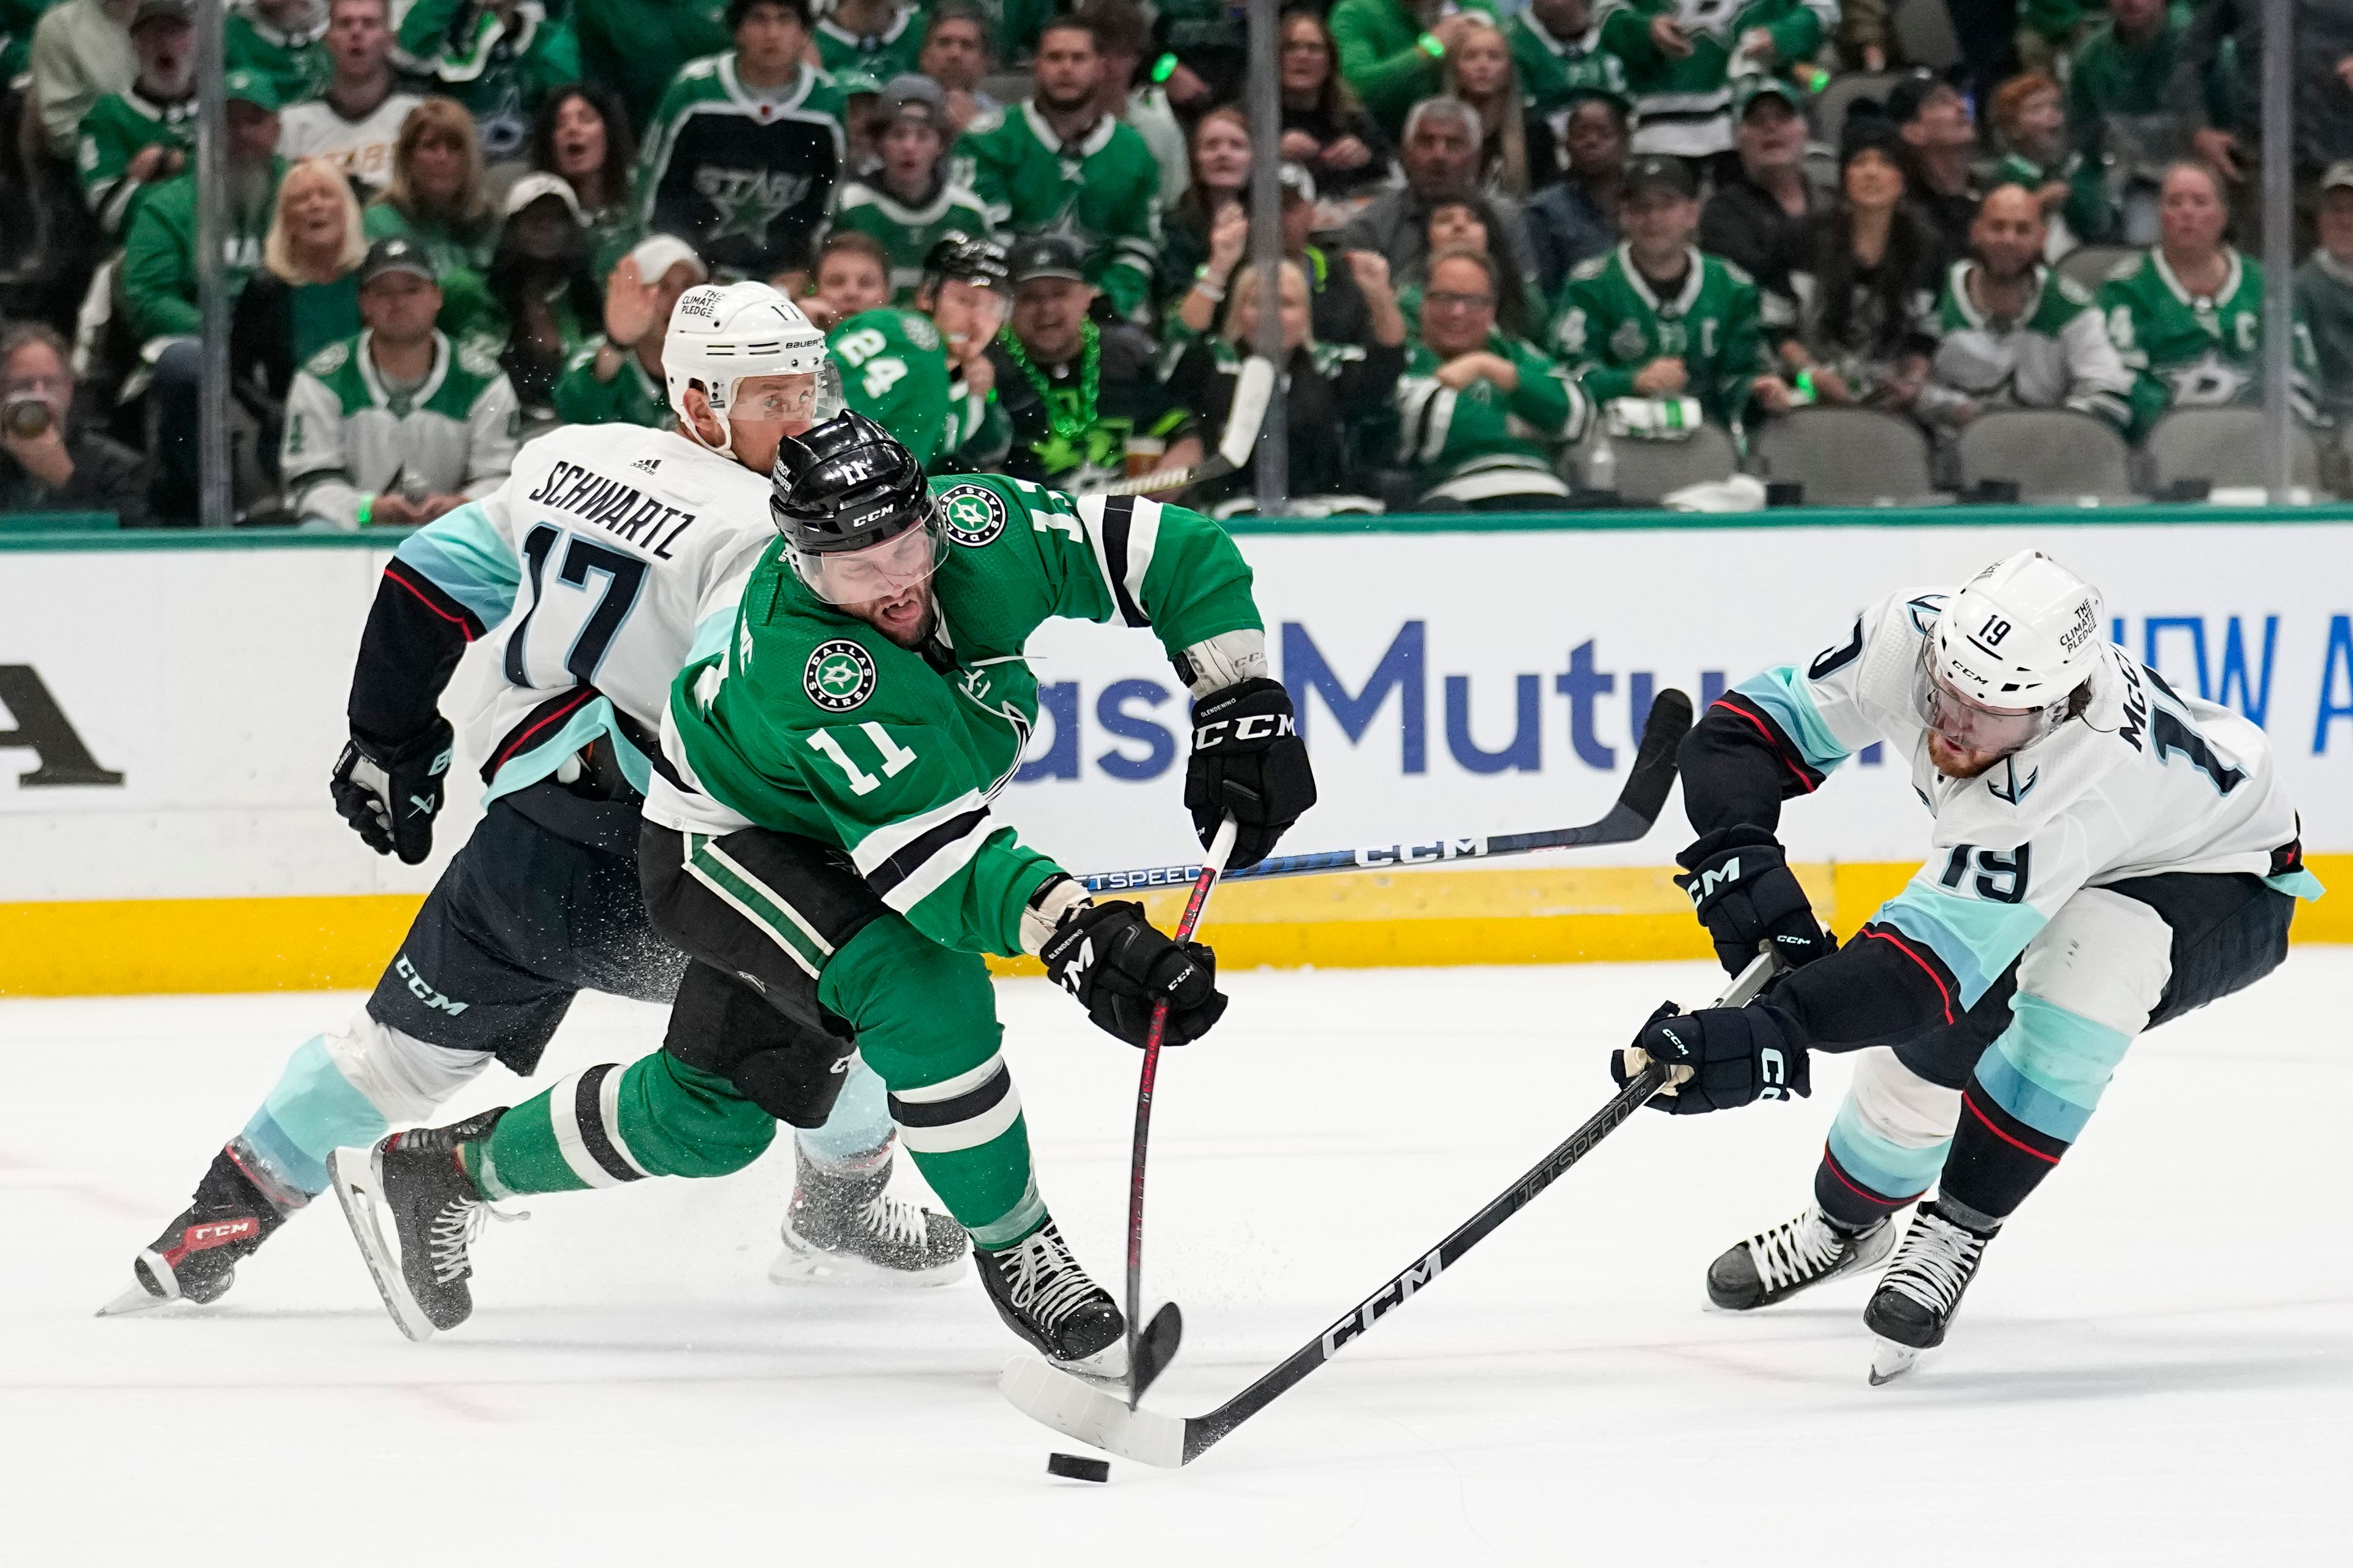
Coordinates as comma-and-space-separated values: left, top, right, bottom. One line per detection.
955, 101, 1160, 318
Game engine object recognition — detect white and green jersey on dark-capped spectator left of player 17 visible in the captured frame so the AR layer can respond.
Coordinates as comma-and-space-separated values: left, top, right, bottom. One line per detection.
278, 332, 522, 528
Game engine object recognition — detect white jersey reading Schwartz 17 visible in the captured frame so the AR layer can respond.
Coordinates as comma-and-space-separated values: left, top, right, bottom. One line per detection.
395, 424, 776, 798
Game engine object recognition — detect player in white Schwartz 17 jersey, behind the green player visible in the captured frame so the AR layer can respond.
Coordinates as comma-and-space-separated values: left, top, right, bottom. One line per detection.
108, 282, 967, 1311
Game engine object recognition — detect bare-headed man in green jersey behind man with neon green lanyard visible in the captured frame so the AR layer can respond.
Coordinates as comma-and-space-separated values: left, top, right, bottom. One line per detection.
955, 19, 1160, 320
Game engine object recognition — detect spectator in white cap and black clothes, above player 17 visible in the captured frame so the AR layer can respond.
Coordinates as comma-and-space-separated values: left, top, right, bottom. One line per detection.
487, 174, 605, 414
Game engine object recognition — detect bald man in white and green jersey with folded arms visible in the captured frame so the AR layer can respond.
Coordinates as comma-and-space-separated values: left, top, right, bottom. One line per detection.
1913, 186, 2132, 433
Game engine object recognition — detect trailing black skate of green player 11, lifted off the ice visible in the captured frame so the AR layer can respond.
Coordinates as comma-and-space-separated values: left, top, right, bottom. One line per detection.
327, 1104, 506, 1344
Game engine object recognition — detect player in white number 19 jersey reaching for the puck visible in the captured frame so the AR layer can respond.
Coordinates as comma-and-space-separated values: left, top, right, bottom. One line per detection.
1612, 551, 2320, 1382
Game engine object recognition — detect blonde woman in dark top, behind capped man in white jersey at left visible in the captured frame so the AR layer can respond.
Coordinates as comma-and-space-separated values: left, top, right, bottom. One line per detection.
228, 157, 367, 414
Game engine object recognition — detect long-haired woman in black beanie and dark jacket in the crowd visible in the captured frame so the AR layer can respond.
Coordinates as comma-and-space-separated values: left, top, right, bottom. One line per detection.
1765, 115, 1944, 412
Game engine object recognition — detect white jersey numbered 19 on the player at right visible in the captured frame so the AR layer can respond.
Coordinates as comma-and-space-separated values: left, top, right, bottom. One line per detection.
1734, 589, 2320, 1006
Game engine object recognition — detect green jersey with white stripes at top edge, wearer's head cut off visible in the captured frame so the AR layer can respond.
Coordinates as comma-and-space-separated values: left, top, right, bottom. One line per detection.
1600, 0, 1838, 157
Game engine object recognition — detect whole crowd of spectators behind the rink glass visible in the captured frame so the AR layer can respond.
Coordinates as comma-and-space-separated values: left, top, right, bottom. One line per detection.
0, 0, 2353, 528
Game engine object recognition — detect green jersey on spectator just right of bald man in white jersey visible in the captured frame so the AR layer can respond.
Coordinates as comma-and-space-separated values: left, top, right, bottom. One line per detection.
2099, 247, 2316, 441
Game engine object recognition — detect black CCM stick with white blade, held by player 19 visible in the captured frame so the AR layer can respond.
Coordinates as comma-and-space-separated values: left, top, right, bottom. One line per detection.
998, 953, 1774, 1469
